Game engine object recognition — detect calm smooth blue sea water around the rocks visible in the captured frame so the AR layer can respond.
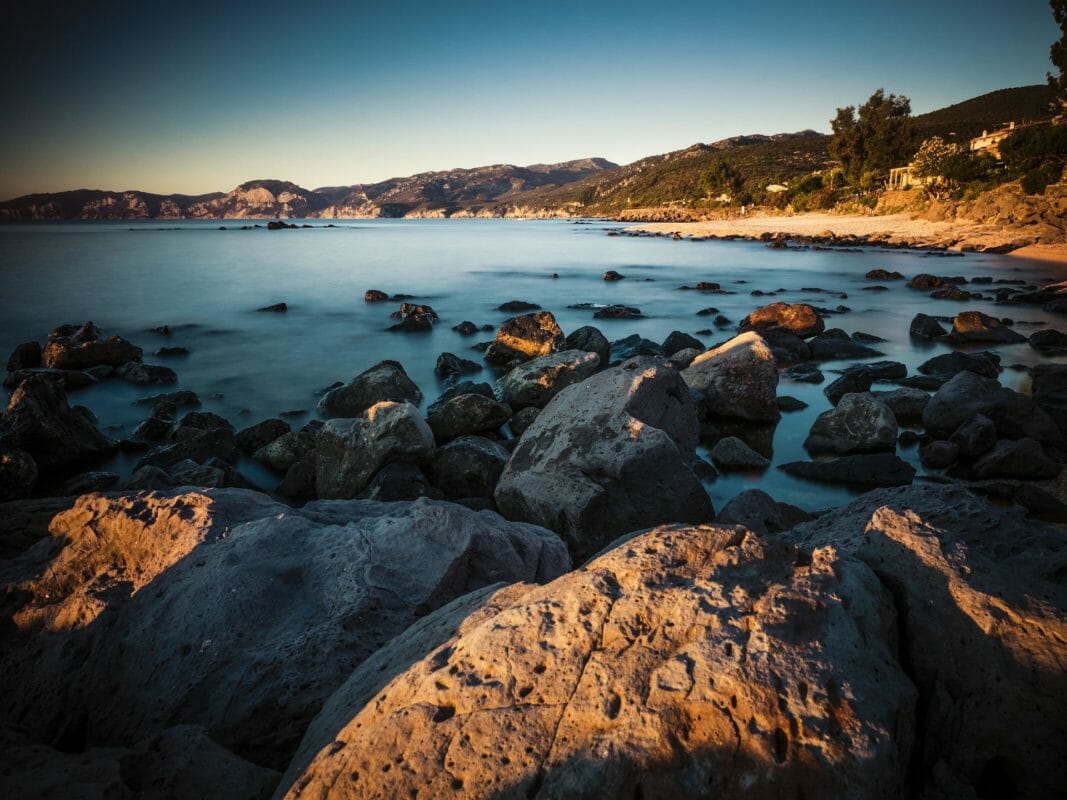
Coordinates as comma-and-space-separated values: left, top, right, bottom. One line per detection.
0, 220, 1067, 509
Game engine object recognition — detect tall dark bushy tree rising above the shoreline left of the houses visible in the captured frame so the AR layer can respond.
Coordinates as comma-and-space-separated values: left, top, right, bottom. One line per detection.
830, 89, 914, 182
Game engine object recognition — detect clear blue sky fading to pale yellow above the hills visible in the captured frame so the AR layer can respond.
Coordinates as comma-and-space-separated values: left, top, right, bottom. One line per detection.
0, 0, 1060, 198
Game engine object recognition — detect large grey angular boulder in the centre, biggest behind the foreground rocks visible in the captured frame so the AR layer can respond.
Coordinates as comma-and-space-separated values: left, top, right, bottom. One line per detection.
495, 358, 714, 556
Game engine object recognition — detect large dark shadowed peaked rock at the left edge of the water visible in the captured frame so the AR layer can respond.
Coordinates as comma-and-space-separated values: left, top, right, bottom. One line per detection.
0, 375, 114, 470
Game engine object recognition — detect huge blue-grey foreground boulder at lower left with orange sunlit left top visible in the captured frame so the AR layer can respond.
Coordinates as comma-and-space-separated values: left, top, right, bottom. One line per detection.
0, 488, 569, 767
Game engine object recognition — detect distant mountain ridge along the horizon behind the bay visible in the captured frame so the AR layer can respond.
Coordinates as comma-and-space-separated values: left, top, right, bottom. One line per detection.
0, 84, 1053, 221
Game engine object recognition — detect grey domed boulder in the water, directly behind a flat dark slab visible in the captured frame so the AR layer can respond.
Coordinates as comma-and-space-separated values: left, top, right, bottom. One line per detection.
803, 393, 897, 455
